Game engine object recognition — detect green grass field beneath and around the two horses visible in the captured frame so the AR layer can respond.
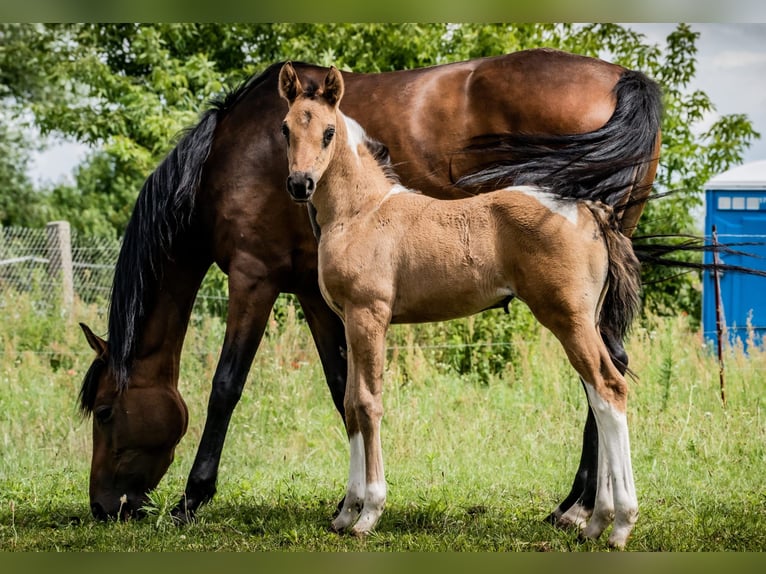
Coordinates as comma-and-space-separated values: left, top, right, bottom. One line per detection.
0, 297, 766, 552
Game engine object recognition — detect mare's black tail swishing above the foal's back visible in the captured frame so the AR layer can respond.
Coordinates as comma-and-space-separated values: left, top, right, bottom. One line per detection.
455, 70, 662, 206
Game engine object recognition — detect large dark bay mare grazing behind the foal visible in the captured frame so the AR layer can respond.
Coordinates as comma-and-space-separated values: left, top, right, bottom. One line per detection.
80, 49, 660, 521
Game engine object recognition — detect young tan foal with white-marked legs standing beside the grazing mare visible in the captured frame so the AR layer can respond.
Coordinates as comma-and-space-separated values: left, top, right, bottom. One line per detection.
279, 63, 641, 547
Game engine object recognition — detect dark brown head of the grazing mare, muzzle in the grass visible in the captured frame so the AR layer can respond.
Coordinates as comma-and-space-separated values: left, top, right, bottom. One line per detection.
80, 324, 188, 520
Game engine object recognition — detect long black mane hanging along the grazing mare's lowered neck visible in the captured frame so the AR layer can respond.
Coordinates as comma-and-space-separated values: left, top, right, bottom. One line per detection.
109, 109, 218, 389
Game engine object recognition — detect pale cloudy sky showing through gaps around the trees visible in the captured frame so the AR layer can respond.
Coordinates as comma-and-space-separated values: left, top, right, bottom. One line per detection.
30, 23, 766, 183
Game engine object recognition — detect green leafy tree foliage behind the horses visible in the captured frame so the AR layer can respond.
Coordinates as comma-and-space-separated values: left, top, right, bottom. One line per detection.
0, 23, 759, 320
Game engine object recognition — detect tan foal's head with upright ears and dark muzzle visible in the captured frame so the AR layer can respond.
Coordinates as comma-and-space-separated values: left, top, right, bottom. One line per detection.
279, 62, 343, 202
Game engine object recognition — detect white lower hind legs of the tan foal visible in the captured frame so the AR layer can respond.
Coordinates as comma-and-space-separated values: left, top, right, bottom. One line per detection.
583, 383, 638, 548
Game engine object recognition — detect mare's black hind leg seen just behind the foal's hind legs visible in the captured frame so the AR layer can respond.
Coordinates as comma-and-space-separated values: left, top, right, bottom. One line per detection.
545, 331, 628, 527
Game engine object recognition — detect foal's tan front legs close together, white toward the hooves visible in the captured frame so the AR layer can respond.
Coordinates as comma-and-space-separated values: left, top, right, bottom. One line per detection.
332, 305, 390, 536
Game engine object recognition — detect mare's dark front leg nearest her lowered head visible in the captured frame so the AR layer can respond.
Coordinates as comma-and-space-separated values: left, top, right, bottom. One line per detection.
172, 272, 279, 522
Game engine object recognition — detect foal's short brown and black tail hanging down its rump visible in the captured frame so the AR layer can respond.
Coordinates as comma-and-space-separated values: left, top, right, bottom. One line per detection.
585, 205, 641, 341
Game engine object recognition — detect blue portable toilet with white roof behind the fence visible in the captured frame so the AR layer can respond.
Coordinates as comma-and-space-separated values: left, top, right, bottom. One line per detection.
702, 160, 766, 348
